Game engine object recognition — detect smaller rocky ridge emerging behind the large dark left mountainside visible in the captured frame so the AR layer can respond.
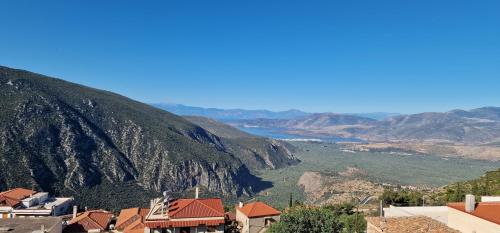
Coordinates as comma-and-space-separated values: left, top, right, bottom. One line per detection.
185, 116, 299, 169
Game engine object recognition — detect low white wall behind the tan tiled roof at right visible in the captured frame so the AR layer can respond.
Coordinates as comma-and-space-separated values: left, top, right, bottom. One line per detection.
384, 206, 448, 224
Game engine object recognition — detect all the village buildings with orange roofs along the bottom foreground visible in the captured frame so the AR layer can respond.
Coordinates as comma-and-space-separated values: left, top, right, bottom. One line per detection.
0, 188, 500, 233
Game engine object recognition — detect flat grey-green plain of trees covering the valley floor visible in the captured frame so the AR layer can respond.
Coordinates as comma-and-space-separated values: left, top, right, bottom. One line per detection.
254, 142, 500, 208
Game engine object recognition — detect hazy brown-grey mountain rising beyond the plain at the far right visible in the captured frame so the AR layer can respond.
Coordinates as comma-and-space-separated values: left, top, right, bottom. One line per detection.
361, 107, 500, 144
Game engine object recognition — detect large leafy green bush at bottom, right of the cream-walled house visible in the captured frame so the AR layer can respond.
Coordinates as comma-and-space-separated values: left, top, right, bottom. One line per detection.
268, 204, 366, 233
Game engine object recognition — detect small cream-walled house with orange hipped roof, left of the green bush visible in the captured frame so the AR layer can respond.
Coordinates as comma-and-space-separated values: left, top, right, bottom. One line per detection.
236, 201, 281, 233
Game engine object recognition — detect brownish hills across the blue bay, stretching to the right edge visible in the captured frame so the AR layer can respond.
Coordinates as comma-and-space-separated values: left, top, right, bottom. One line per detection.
231, 107, 500, 144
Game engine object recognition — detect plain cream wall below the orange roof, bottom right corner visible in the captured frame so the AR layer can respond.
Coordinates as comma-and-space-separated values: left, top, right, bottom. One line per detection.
448, 208, 500, 233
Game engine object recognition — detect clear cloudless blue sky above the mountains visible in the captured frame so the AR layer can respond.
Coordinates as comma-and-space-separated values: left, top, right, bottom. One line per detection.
0, 0, 500, 113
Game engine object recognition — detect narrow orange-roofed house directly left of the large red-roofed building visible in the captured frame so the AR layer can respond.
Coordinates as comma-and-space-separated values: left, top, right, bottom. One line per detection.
115, 208, 149, 233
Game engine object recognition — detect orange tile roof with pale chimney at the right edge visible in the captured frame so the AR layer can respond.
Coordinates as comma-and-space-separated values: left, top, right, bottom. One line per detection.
448, 202, 500, 224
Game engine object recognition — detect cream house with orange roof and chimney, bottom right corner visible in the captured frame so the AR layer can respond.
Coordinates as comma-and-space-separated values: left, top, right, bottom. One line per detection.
448, 195, 500, 233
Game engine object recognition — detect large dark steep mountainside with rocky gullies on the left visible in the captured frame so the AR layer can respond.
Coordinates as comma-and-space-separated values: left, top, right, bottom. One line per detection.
0, 67, 280, 208
